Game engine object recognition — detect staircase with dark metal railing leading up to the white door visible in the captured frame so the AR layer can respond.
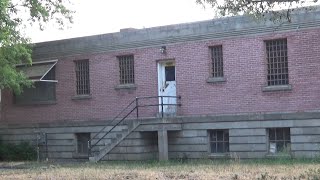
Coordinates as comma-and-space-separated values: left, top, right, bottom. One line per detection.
88, 96, 181, 162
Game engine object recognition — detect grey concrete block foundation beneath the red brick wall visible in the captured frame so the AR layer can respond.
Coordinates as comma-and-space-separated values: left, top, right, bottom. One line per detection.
0, 112, 320, 160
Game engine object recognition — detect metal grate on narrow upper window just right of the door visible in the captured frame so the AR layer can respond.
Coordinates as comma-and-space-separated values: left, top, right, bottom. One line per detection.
210, 45, 223, 77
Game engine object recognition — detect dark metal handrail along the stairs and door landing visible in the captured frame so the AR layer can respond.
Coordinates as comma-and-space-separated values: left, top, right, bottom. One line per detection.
88, 96, 181, 156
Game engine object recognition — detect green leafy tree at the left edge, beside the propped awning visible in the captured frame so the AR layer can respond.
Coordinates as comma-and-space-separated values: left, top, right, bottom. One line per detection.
0, 0, 73, 94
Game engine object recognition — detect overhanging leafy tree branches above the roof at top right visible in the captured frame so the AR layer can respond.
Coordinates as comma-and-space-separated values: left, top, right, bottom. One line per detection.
196, 0, 319, 22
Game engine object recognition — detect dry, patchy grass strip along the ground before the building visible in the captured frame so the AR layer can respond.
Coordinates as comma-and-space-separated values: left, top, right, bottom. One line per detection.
0, 159, 320, 180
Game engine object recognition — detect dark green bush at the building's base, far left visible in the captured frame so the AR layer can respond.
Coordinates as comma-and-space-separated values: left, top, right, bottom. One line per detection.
0, 142, 37, 161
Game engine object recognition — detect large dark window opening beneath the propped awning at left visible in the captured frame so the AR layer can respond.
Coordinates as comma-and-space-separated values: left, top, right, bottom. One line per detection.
14, 67, 56, 104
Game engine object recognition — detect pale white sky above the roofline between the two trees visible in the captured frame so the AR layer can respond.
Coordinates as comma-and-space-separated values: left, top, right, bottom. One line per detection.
26, 0, 214, 43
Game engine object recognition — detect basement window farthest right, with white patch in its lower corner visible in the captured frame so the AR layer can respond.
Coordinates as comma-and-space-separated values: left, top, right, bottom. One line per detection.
268, 128, 290, 153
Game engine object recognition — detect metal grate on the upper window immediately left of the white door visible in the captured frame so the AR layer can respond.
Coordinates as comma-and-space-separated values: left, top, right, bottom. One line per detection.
118, 55, 134, 84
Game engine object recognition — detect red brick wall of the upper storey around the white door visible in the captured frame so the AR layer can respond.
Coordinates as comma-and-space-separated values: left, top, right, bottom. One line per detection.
2, 29, 320, 122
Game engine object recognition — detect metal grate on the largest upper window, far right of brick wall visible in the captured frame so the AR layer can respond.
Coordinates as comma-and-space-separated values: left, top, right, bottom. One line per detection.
265, 39, 289, 86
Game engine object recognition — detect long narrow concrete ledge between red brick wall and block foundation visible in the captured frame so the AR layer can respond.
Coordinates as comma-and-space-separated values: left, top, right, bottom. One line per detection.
0, 111, 320, 130
